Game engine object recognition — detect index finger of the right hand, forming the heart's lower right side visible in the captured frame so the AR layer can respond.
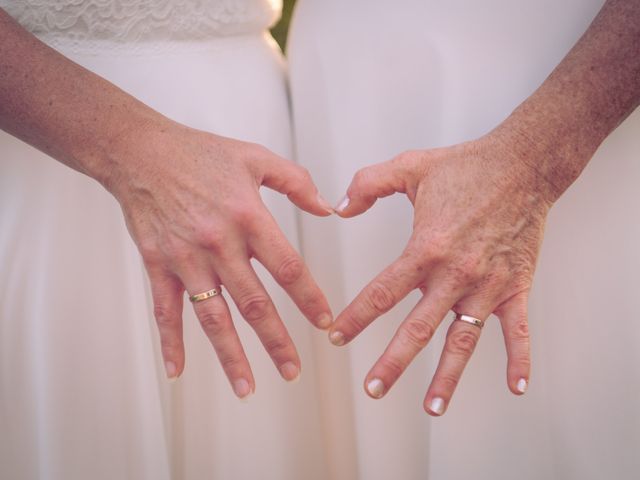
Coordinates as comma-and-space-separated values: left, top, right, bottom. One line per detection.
329, 251, 425, 346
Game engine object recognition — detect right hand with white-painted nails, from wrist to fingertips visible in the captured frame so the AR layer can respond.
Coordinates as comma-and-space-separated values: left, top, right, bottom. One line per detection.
329, 130, 551, 415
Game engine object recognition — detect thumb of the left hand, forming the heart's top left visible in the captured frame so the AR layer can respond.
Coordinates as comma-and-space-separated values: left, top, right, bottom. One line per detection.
262, 152, 333, 217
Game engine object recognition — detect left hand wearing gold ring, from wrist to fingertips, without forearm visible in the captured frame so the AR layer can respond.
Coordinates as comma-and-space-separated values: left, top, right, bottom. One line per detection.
103, 121, 332, 397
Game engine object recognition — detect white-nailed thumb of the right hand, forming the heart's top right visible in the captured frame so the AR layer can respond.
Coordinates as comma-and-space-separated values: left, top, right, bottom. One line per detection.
335, 155, 416, 218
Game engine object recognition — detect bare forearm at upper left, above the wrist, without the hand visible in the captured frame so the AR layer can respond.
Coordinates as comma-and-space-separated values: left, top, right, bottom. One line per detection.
0, 9, 162, 188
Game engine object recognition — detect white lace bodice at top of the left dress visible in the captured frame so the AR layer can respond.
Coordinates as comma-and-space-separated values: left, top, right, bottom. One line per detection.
0, 0, 282, 50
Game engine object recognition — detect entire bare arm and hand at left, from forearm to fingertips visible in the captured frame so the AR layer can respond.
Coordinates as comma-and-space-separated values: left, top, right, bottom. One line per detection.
0, 10, 332, 397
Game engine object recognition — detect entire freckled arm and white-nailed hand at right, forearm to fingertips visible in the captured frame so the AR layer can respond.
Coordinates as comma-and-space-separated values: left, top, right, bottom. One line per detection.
330, 0, 640, 415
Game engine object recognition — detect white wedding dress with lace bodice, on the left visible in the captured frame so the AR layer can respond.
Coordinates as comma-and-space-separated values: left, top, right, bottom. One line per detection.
0, 0, 330, 480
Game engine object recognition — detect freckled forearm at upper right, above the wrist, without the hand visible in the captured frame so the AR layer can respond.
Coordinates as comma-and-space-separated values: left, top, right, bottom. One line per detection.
501, 0, 640, 201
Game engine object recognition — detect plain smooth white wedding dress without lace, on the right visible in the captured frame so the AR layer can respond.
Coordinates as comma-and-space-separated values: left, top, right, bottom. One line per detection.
287, 0, 640, 480
